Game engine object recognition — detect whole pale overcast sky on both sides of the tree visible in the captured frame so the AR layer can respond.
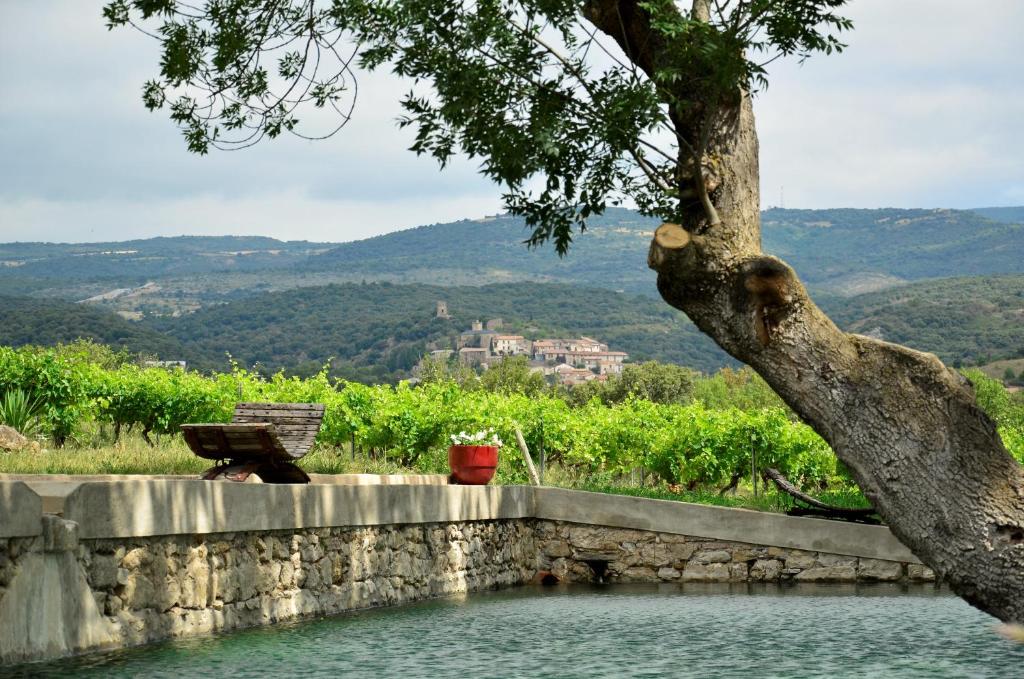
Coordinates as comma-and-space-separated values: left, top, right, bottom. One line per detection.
0, 0, 1024, 242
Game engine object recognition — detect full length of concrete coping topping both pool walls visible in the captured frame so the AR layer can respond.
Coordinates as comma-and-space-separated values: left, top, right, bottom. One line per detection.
0, 479, 920, 563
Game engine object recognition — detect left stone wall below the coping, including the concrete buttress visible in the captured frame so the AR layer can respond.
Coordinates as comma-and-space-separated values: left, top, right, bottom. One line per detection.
0, 519, 537, 662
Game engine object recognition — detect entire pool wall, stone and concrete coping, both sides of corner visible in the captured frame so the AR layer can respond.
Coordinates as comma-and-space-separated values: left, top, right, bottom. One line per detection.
0, 479, 934, 664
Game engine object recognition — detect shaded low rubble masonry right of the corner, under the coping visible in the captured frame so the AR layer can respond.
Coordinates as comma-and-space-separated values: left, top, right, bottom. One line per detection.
534, 520, 935, 583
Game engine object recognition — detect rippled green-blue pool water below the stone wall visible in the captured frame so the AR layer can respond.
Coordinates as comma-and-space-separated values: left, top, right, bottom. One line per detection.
9, 585, 1024, 679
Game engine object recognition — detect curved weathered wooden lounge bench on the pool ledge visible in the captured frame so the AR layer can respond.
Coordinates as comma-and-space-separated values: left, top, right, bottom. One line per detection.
181, 404, 324, 483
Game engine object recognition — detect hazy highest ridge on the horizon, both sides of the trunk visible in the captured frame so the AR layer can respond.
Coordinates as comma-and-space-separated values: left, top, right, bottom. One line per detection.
306, 208, 1024, 295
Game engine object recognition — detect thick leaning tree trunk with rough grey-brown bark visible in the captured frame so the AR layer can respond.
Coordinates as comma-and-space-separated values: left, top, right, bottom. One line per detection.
586, 0, 1024, 622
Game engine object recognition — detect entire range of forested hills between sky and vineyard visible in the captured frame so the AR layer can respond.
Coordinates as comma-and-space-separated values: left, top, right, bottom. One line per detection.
0, 202, 1024, 381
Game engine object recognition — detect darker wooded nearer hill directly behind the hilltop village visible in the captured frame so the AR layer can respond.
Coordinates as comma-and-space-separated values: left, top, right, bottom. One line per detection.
144, 283, 733, 380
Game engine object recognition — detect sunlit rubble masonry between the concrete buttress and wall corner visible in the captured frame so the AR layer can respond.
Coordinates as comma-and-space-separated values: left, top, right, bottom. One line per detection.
79, 521, 537, 644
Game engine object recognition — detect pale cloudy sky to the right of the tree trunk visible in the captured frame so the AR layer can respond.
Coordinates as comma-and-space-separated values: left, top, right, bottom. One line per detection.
757, 0, 1024, 208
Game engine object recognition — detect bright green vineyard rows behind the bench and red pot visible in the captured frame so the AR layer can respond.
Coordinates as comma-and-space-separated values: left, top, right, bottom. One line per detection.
6, 346, 1024, 491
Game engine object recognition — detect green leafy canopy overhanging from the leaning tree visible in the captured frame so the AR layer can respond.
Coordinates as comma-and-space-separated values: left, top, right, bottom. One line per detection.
103, 0, 851, 253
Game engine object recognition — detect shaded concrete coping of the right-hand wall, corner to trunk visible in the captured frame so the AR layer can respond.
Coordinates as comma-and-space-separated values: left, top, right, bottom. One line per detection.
535, 487, 921, 563
